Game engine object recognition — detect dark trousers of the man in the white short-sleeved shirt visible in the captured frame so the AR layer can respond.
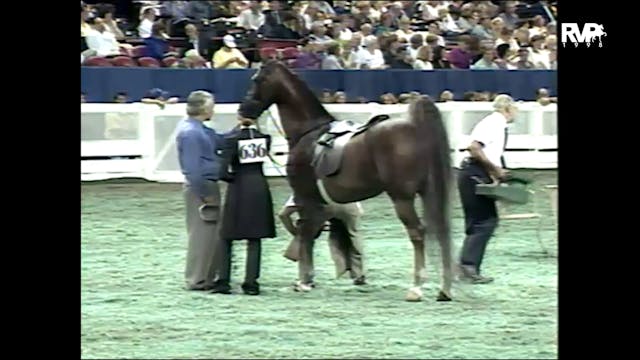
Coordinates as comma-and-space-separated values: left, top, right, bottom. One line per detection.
458, 161, 498, 274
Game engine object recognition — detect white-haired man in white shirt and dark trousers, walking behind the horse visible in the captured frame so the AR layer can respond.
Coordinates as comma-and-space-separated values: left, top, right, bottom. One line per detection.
458, 94, 518, 284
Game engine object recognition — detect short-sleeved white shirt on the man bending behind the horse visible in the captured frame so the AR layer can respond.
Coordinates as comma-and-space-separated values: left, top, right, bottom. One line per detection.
470, 112, 507, 167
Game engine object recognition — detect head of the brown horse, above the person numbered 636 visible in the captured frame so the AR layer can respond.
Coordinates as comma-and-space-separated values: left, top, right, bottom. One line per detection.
239, 60, 286, 119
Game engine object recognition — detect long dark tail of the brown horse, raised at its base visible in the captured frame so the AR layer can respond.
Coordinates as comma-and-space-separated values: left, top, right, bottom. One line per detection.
410, 96, 453, 292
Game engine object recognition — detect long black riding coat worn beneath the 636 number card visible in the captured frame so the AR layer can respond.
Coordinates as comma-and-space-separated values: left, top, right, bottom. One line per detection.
221, 127, 276, 240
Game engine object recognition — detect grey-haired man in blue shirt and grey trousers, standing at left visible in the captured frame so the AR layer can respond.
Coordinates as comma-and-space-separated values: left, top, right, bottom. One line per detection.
176, 91, 221, 290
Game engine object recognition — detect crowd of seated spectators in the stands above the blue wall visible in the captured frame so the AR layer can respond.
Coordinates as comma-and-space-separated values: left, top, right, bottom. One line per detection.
81, 1, 557, 70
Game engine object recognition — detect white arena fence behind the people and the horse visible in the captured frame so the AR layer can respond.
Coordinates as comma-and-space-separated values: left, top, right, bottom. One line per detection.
80, 102, 558, 182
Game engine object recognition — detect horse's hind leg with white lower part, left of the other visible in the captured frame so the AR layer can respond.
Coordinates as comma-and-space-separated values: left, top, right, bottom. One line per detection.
393, 199, 427, 301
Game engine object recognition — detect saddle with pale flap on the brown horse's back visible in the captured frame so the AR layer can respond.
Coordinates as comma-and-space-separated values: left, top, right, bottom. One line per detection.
311, 115, 389, 179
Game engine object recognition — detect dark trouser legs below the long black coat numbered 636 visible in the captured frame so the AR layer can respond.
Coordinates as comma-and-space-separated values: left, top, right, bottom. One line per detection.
218, 239, 262, 285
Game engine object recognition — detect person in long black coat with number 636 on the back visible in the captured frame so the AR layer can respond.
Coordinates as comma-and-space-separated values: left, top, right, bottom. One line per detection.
213, 117, 276, 295
